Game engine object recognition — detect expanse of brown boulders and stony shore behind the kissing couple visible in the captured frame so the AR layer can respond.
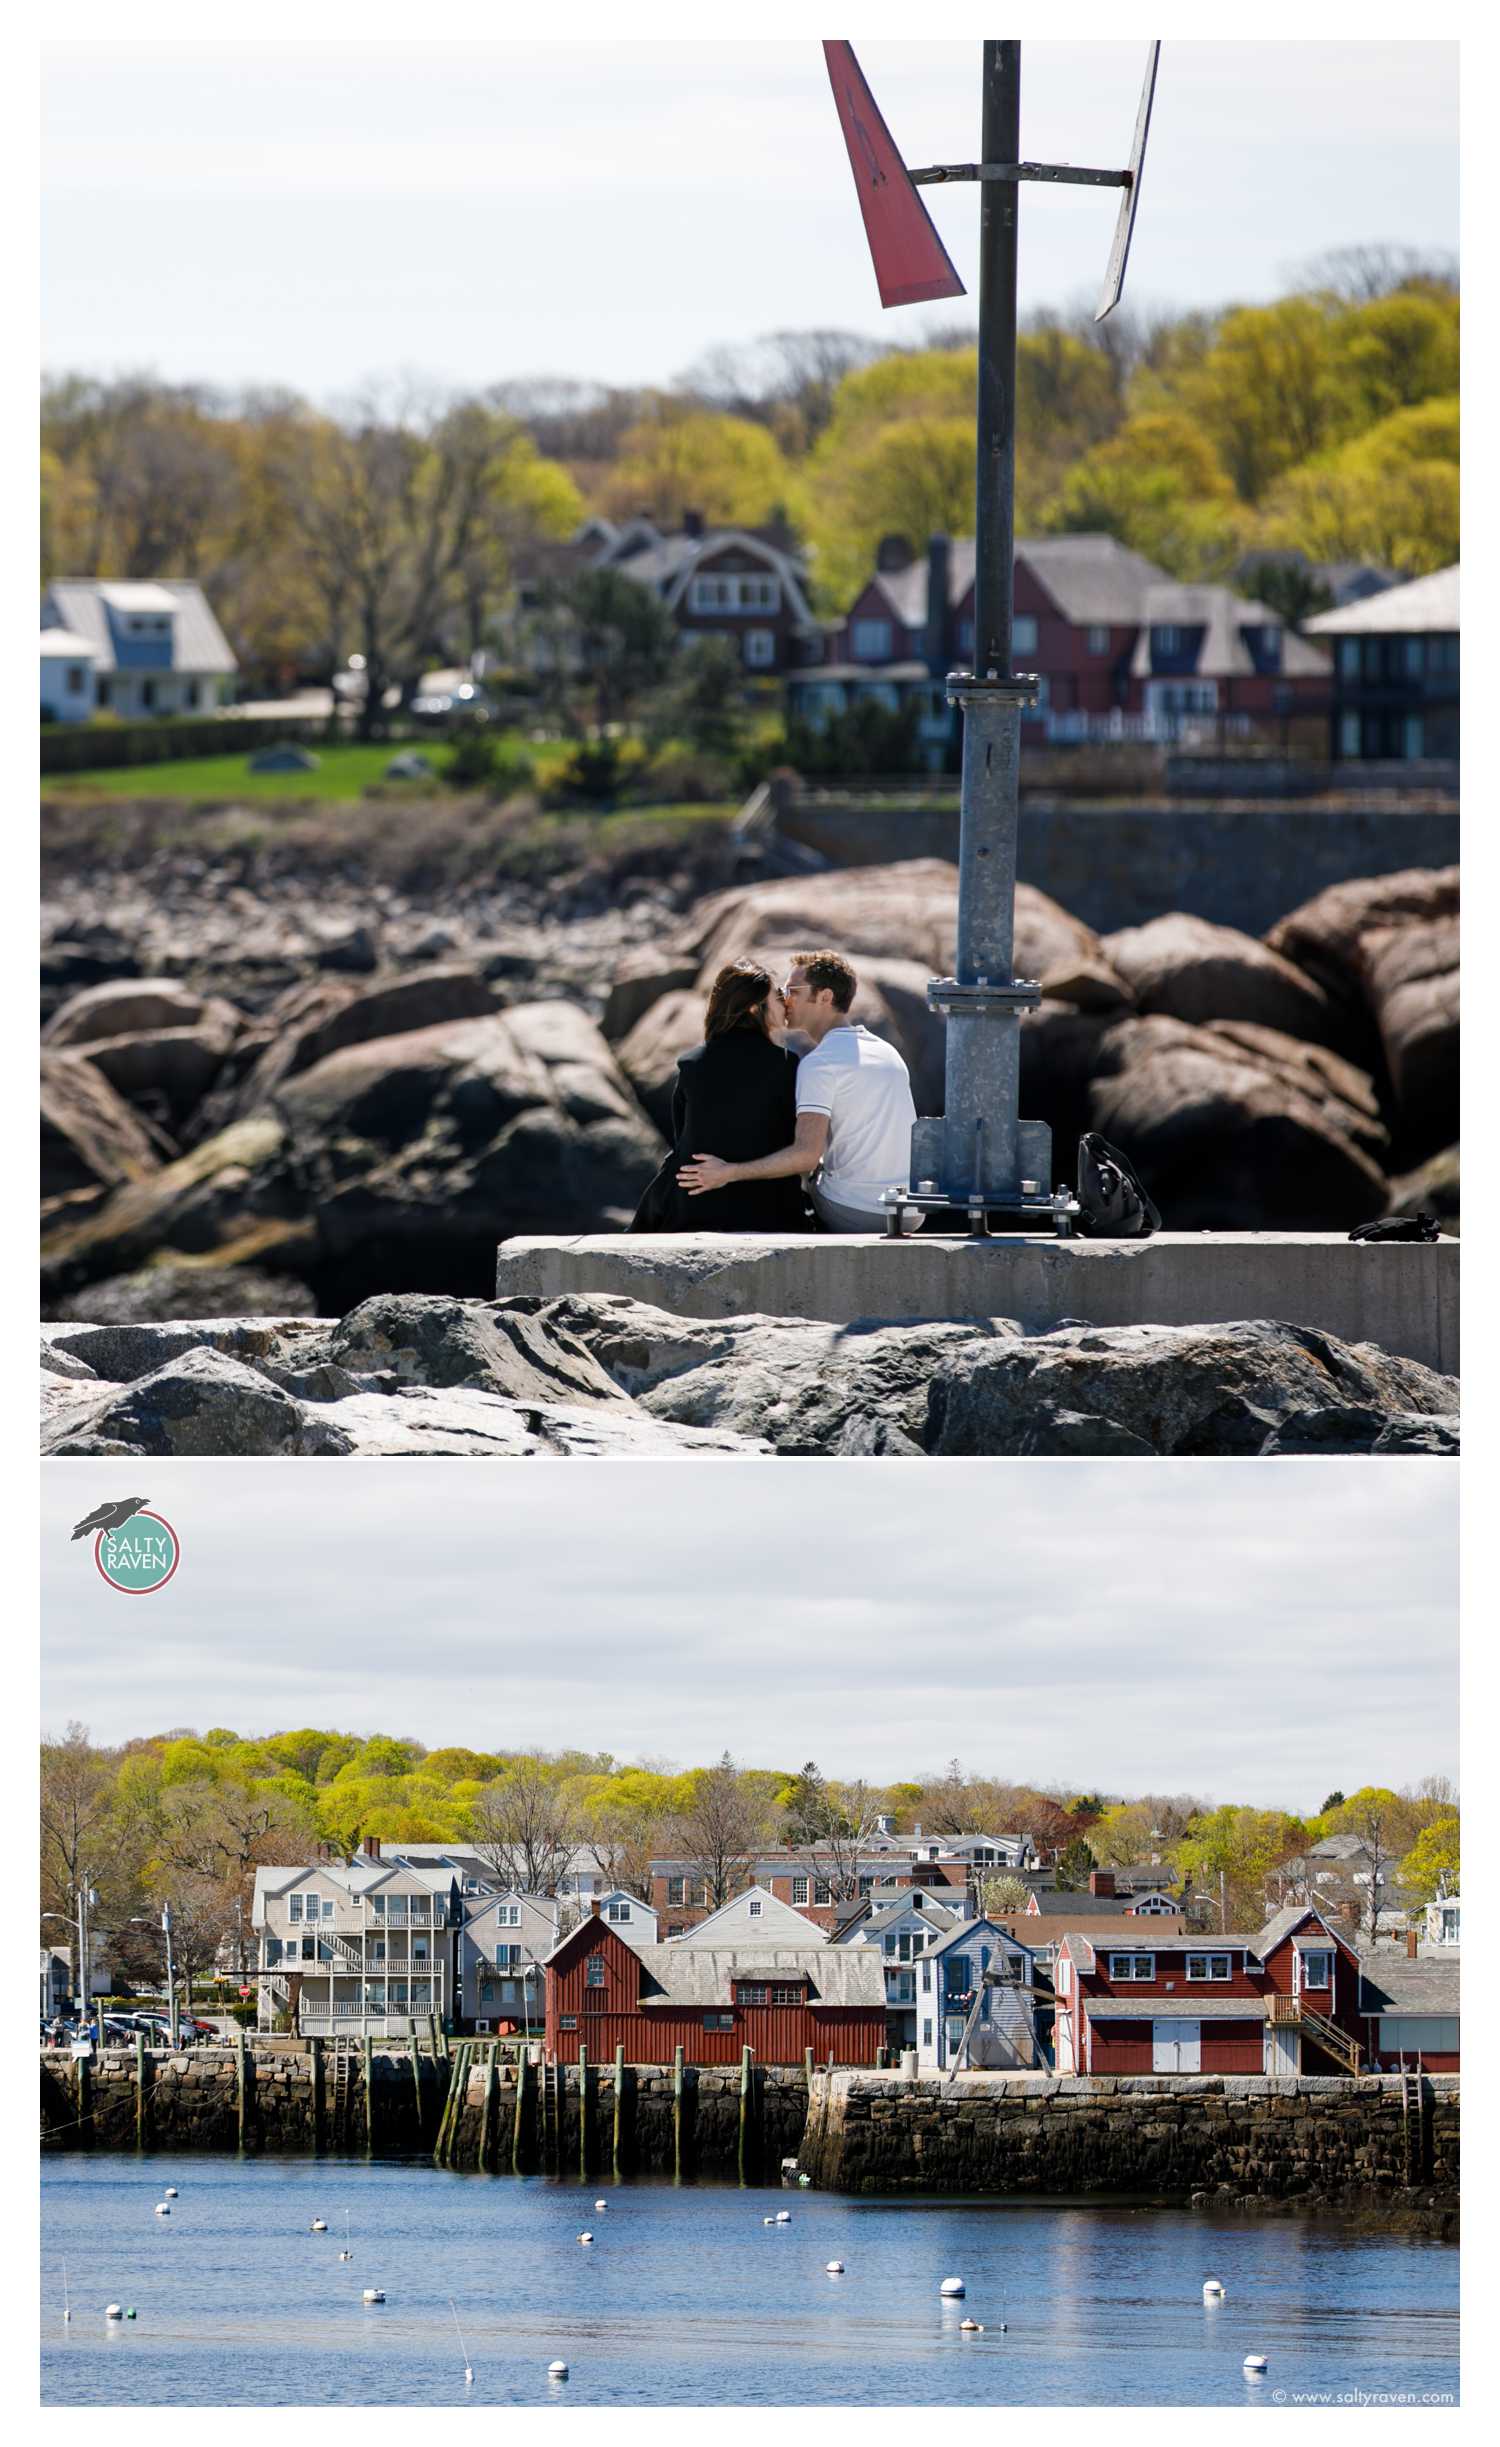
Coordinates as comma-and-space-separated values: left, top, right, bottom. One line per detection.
42, 817, 1458, 1321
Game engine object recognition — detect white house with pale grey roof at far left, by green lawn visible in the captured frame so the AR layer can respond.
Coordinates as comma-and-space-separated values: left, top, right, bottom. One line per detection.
42, 577, 240, 722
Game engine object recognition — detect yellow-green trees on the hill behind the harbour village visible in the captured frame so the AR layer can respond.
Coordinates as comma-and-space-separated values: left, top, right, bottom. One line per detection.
42, 1725, 1458, 1977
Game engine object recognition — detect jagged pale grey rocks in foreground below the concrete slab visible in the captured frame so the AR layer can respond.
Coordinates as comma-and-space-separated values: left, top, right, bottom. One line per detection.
42, 1294, 1458, 1458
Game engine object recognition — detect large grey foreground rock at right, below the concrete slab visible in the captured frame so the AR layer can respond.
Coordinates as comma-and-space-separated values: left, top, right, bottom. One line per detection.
923, 1321, 1458, 1454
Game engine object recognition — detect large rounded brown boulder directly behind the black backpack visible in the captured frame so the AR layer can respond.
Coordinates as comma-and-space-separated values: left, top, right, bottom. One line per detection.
1089, 1018, 1385, 1231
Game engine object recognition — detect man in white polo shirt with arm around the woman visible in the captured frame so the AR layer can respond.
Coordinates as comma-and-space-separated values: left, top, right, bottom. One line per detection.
678, 952, 923, 1231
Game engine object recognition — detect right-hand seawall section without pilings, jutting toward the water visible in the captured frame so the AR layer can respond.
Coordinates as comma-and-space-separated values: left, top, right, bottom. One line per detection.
798, 2073, 1458, 2210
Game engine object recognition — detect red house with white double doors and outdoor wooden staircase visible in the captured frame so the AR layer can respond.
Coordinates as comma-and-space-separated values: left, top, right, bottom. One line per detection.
1052, 1904, 1368, 2078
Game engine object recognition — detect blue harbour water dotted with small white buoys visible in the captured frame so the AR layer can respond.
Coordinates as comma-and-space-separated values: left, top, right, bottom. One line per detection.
42, 2153, 1458, 2408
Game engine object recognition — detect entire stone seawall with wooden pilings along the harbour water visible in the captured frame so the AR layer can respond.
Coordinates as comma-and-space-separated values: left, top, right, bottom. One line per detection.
42, 2041, 1458, 2232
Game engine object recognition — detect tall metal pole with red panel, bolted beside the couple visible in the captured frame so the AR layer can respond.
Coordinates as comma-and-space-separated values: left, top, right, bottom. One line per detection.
825, 42, 1160, 1238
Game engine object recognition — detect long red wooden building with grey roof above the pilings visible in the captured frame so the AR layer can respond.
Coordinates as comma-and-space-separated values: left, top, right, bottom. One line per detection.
543, 1911, 886, 2065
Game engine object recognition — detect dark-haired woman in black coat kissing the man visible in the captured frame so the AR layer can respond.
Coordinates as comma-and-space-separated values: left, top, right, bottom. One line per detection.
631, 959, 810, 1233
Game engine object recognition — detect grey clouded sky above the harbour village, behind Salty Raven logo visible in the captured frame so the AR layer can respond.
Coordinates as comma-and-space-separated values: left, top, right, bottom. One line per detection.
42, 1458, 1458, 1808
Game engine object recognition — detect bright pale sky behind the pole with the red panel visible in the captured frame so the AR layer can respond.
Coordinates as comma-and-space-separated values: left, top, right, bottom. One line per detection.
42, 37, 1458, 399
